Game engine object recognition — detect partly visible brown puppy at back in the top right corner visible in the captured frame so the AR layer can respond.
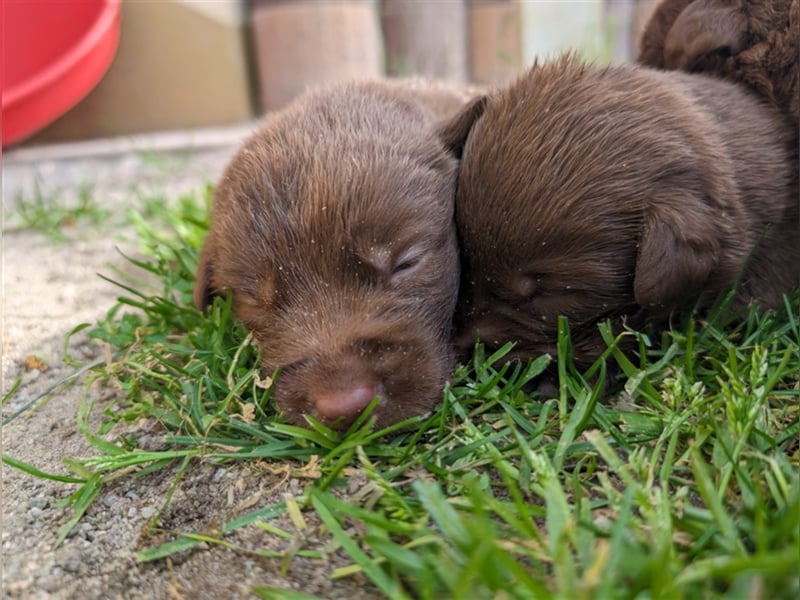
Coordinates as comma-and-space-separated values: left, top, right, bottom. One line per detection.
638, 0, 800, 130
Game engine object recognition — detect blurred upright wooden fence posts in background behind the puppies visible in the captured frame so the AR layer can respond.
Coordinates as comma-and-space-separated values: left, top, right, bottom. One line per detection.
252, 0, 656, 110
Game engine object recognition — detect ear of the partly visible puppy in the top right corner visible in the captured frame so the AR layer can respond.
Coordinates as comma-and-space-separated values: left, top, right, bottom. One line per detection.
664, 0, 748, 71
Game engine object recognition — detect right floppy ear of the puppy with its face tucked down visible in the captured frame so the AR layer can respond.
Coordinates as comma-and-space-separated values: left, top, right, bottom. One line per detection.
633, 192, 721, 308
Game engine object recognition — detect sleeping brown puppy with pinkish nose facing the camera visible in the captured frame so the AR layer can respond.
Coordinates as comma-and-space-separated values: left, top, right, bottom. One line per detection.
195, 82, 476, 427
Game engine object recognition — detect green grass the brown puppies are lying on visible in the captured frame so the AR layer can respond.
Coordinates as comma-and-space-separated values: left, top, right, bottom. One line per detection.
3, 189, 800, 599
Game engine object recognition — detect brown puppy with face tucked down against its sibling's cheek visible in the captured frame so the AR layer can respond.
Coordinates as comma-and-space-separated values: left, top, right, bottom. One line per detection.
441, 57, 800, 366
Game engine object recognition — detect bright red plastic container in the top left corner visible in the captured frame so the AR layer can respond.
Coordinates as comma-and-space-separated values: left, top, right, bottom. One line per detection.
0, 0, 120, 147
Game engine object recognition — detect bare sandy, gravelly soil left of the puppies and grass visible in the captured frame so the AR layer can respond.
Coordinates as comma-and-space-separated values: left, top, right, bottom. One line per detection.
0, 132, 380, 599
